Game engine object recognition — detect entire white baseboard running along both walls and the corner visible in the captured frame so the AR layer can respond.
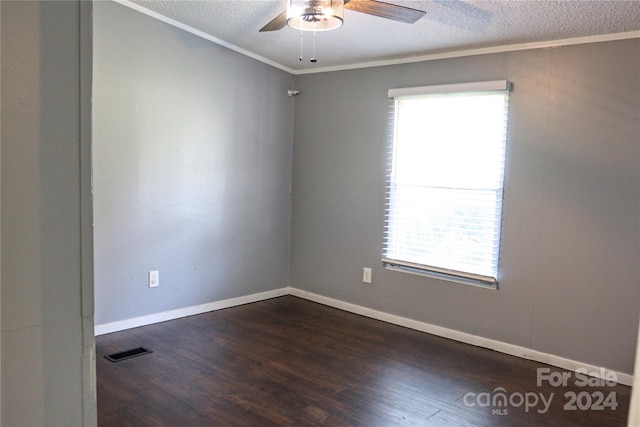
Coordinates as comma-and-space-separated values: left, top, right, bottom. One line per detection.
95, 287, 633, 386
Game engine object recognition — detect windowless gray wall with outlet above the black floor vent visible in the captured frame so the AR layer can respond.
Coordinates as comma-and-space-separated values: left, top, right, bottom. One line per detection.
93, 2, 293, 324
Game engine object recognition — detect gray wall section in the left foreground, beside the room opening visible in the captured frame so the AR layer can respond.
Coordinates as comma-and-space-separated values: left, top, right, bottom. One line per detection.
0, 1, 96, 426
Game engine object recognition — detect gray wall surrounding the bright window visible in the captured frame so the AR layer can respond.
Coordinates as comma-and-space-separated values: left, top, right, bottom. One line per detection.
290, 39, 640, 373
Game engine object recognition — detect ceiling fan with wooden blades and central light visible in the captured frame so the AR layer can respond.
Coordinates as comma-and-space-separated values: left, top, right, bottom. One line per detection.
260, 0, 426, 32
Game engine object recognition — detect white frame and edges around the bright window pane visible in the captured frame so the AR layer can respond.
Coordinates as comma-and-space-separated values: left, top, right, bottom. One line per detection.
382, 80, 512, 289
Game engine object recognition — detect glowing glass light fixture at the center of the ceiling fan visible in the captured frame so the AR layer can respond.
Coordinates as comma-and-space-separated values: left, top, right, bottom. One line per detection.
287, 0, 344, 31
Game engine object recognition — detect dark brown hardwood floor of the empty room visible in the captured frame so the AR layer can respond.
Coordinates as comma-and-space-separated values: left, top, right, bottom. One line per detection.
96, 296, 630, 427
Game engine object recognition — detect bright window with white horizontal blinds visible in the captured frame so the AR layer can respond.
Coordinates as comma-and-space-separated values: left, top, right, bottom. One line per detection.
382, 81, 510, 289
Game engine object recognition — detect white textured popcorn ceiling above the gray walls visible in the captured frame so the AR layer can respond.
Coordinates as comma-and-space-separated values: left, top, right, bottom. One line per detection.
126, 0, 640, 72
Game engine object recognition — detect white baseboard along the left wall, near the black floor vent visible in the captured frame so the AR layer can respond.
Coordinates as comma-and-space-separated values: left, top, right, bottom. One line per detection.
94, 288, 289, 336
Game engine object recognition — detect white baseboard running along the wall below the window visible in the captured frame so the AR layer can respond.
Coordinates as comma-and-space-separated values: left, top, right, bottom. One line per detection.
287, 287, 633, 386
